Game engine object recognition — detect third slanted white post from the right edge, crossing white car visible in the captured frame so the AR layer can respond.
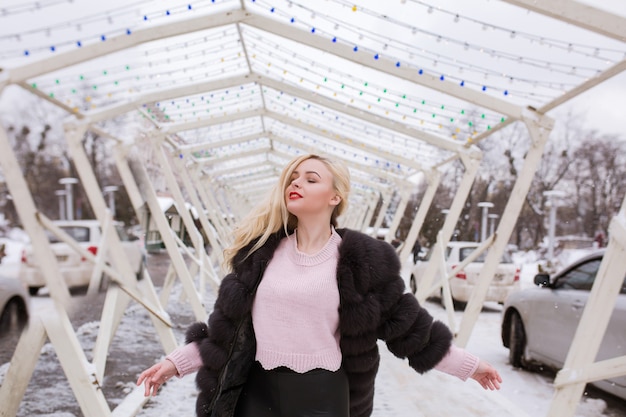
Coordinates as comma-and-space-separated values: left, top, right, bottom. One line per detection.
416, 153, 481, 303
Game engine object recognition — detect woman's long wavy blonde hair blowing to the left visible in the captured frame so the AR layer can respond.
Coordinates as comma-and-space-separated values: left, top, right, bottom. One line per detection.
224, 154, 350, 270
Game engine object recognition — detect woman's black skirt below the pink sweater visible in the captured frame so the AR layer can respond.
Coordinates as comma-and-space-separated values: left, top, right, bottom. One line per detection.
235, 362, 350, 417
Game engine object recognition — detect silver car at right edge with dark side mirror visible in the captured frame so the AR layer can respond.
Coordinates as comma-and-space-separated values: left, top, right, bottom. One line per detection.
502, 251, 626, 399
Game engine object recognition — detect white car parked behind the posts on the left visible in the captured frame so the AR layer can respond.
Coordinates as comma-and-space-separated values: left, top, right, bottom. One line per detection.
19, 220, 145, 295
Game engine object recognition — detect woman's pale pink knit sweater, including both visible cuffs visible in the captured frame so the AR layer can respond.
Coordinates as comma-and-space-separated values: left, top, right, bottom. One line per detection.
167, 230, 478, 380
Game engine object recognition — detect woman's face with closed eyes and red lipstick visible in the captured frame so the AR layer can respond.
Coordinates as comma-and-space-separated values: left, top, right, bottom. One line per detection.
285, 159, 341, 219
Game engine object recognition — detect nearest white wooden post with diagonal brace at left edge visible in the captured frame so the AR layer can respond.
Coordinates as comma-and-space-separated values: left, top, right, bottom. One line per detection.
0, 127, 116, 417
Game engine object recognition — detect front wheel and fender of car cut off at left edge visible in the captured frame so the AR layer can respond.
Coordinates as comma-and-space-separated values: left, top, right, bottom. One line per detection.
0, 276, 29, 336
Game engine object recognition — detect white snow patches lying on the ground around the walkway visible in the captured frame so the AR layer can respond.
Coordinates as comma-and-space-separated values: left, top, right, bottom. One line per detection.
0, 239, 626, 417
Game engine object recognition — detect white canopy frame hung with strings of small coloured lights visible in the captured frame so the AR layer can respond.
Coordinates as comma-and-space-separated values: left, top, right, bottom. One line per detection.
0, 0, 626, 416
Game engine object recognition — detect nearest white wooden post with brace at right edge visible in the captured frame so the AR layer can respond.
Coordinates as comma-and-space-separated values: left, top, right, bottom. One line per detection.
547, 193, 626, 417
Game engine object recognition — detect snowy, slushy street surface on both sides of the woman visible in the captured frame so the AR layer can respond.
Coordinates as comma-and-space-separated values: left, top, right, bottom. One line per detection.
0, 247, 626, 417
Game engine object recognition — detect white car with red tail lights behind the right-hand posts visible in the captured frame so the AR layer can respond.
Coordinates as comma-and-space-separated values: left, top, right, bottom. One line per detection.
408, 241, 520, 309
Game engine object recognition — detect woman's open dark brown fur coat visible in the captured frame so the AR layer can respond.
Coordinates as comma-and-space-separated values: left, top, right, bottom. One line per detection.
187, 229, 452, 417
